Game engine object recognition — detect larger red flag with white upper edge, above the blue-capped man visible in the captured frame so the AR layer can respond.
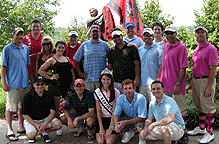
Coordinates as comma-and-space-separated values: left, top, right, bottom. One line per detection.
107, 0, 144, 38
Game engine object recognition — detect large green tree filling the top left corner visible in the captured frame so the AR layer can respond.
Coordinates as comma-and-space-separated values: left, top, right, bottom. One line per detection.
0, 0, 60, 50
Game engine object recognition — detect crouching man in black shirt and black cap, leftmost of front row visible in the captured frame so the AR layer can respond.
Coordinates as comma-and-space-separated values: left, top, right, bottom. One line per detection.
21, 76, 62, 143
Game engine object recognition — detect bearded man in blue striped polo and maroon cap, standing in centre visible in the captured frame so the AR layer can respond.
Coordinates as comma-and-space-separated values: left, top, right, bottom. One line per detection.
73, 24, 110, 92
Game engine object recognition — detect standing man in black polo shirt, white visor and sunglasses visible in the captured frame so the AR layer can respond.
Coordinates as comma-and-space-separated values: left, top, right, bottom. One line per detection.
107, 28, 140, 93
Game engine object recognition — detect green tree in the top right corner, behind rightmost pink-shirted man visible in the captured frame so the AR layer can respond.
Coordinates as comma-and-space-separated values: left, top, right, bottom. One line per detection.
194, 0, 219, 48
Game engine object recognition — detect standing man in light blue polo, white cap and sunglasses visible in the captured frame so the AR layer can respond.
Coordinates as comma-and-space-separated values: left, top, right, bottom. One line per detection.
138, 28, 163, 103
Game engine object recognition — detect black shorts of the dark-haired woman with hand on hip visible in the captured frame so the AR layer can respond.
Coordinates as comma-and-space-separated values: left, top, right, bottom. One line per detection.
48, 84, 71, 98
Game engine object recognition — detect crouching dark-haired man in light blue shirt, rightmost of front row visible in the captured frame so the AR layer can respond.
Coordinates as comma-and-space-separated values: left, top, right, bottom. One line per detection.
140, 81, 185, 144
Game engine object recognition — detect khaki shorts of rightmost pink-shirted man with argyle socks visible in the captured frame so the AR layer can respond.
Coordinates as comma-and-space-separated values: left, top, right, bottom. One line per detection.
192, 78, 216, 114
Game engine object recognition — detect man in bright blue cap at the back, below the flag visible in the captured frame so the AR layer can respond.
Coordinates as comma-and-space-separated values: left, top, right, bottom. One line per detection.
123, 22, 144, 48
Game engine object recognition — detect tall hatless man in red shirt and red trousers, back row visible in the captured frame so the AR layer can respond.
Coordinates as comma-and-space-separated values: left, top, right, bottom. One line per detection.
23, 19, 44, 82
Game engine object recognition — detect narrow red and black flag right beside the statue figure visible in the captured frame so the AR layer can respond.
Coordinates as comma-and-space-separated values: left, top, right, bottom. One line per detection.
101, 6, 115, 42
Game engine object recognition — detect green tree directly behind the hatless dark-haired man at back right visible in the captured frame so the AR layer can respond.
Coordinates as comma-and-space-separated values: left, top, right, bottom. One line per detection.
139, 0, 174, 27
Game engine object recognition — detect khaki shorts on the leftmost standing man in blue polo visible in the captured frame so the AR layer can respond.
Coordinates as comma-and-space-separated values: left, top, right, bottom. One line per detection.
6, 87, 30, 112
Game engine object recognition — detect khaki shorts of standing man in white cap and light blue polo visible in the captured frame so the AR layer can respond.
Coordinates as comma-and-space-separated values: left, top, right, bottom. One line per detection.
139, 85, 155, 103
